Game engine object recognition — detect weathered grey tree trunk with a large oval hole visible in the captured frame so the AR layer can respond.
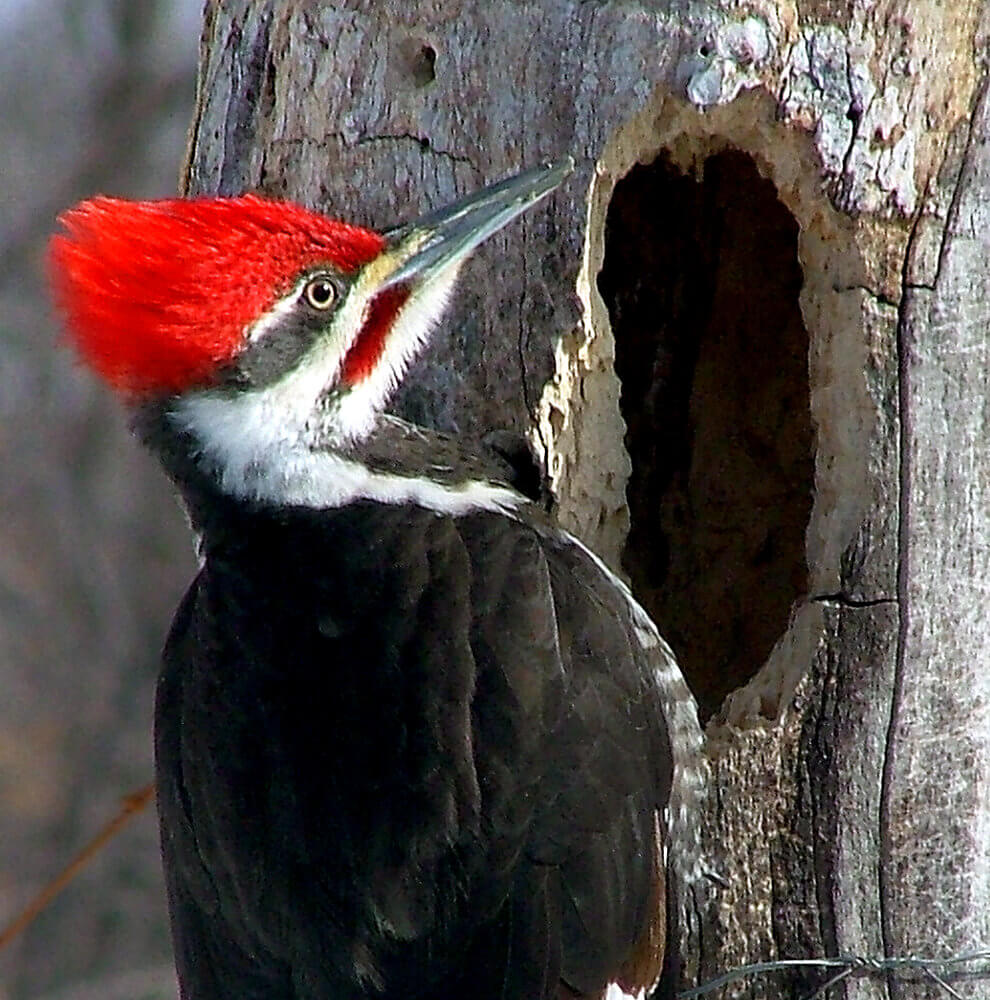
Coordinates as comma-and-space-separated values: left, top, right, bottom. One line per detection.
184, 0, 990, 1000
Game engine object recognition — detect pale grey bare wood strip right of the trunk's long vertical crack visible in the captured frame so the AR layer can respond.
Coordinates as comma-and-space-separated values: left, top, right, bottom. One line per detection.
880, 72, 990, 997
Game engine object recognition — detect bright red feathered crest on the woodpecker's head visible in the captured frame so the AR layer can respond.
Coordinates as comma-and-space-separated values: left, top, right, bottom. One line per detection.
49, 195, 385, 396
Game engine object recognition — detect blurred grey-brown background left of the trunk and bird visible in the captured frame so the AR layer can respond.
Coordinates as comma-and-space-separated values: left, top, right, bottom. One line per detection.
0, 0, 202, 1000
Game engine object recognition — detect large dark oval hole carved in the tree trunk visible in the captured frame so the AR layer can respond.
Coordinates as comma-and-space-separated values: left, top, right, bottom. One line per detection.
598, 150, 814, 718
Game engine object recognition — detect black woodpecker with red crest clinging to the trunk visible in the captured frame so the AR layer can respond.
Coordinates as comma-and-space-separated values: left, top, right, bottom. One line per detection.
49, 161, 704, 1000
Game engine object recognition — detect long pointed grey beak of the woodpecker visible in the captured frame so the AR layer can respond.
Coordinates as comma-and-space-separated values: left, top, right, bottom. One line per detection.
381, 157, 574, 289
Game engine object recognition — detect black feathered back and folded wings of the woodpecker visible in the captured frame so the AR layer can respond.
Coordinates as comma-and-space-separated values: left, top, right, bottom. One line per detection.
156, 503, 671, 1000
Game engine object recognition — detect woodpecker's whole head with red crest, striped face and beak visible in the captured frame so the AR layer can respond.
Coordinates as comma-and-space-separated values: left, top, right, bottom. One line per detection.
49, 160, 573, 508
